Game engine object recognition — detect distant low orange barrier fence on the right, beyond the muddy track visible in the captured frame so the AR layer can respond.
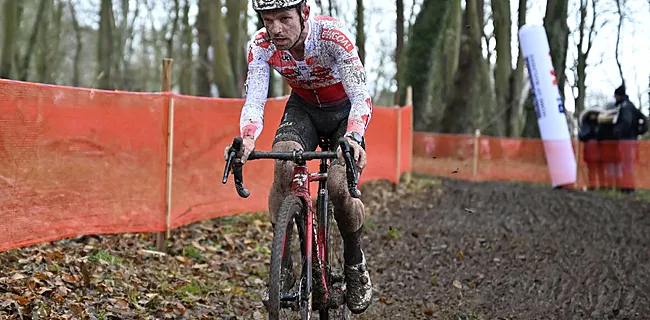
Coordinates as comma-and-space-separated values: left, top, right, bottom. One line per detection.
412, 132, 650, 189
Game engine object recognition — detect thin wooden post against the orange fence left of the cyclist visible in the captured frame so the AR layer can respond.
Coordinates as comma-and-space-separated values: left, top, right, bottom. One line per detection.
156, 58, 174, 252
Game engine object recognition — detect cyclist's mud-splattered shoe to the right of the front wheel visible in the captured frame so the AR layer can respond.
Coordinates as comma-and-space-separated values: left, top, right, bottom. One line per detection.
345, 251, 372, 314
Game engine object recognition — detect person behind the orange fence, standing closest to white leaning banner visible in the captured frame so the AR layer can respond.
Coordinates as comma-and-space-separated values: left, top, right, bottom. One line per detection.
578, 106, 605, 190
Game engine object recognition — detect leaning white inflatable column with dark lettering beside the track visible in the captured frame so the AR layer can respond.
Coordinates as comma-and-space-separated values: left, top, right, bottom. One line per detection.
519, 25, 576, 187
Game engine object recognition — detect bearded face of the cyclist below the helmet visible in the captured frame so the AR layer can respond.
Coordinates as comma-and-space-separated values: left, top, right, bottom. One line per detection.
262, 6, 309, 50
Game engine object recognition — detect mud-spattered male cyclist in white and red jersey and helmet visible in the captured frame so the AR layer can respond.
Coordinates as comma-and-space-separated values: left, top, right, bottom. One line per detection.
226, 0, 372, 314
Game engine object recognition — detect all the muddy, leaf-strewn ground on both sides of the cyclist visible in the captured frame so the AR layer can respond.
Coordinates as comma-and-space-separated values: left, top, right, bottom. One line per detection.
0, 178, 650, 319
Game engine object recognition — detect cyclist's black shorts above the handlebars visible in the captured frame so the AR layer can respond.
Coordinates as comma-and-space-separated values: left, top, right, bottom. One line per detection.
273, 92, 366, 151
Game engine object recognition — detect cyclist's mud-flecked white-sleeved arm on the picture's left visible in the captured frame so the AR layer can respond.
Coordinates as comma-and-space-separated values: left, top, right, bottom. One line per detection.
239, 31, 270, 139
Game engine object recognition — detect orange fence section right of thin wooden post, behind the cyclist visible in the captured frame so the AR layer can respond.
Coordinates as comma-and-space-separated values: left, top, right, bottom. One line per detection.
172, 95, 411, 228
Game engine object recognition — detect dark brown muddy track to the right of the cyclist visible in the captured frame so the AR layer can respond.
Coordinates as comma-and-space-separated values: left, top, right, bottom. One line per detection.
361, 180, 650, 319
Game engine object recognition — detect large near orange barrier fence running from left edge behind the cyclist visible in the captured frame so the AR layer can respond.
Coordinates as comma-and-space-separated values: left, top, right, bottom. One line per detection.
0, 79, 412, 252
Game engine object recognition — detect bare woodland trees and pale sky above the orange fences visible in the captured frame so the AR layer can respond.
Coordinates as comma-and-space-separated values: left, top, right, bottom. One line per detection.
0, 0, 650, 137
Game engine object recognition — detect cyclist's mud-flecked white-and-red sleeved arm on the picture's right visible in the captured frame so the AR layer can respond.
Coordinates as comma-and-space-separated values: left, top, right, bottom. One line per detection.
321, 21, 372, 136
